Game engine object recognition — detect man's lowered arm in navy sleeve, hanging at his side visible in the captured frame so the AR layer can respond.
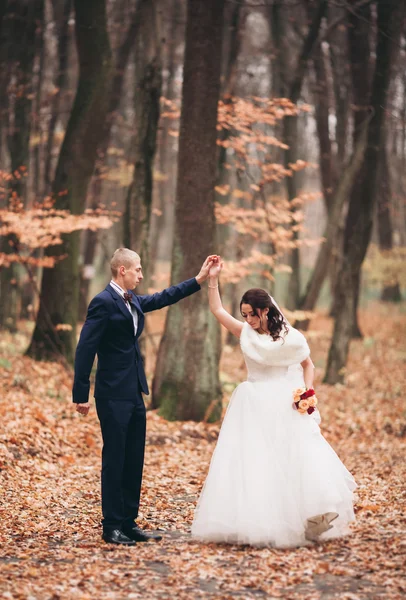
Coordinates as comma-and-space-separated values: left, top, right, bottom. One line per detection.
72, 296, 108, 404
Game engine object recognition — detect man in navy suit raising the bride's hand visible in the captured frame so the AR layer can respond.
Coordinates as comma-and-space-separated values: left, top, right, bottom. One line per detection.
72, 248, 213, 546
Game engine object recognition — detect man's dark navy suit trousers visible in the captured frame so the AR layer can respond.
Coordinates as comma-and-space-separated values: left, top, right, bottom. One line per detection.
96, 392, 146, 531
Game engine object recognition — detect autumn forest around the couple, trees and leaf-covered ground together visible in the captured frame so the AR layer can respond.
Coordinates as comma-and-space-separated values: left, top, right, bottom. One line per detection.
0, 0, 406, 600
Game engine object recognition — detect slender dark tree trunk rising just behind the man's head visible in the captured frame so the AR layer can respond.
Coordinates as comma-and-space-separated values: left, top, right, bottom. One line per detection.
124, 0, 162, 290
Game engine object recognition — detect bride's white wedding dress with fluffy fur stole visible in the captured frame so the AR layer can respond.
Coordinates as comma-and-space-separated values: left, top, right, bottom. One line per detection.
192, 323, 356, 547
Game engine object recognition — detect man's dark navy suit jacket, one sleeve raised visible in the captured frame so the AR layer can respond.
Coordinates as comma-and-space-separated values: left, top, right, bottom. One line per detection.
72, 278, 200, 404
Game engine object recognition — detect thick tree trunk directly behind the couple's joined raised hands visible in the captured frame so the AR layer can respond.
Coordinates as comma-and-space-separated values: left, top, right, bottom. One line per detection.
153, 0, 224, 421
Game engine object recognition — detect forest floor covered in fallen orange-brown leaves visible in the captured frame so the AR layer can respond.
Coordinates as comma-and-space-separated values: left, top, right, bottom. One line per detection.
0, 303, 406, 600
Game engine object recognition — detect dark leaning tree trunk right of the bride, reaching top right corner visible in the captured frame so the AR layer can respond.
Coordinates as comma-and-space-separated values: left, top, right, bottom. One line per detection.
324, 0, 402, 384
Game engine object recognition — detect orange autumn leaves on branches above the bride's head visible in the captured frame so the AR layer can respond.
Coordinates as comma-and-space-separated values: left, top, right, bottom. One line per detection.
161, 97, 320, 283
